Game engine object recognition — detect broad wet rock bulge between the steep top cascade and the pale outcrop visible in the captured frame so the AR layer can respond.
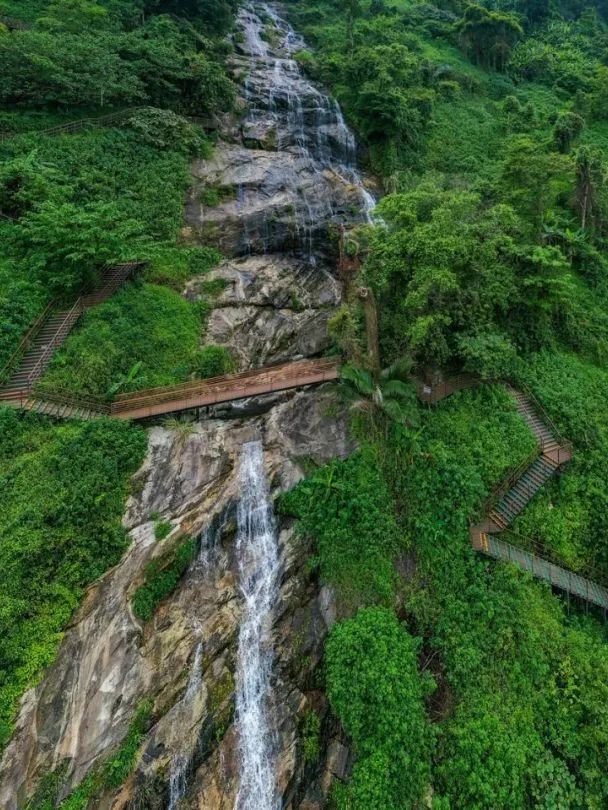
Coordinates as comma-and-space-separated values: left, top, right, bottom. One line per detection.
184, 144, 361, 257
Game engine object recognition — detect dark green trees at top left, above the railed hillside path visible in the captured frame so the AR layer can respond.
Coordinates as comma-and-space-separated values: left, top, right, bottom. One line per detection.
0, 8, 233, 115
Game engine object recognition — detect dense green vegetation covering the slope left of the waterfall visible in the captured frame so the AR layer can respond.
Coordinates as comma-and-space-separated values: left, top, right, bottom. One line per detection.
0, 0, 234, 756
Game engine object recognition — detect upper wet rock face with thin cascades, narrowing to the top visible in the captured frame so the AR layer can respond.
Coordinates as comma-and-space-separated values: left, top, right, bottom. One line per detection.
183, 9, 373, 257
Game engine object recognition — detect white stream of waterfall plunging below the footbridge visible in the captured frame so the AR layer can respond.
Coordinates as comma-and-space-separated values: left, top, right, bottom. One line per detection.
235, 441, 280, 810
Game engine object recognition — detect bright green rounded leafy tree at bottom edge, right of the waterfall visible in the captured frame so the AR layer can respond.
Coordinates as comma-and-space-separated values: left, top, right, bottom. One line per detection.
326, 608, 432, 810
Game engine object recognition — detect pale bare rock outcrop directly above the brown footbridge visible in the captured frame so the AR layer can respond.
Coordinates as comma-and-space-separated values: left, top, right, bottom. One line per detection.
185, 256, 340, 370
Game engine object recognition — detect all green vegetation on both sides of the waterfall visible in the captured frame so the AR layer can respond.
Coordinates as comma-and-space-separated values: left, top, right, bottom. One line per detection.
0, 0, 608, 810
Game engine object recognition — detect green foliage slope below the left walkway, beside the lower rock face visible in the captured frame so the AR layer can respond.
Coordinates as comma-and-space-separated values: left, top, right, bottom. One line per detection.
0, 409, 146, 742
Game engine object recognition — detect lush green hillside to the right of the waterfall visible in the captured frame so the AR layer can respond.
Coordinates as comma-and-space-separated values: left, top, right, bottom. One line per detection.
284, 0, 608, 810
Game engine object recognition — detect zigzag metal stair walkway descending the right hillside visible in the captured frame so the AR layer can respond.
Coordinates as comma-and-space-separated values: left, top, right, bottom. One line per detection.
416, 374, 608, 611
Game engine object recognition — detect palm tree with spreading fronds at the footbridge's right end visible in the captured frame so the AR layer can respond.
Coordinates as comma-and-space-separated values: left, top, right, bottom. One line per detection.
339, 360, 418, 427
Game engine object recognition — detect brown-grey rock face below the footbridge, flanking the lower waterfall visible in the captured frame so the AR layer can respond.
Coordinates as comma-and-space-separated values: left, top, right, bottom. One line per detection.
0, 389, 352, 810
